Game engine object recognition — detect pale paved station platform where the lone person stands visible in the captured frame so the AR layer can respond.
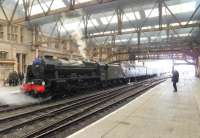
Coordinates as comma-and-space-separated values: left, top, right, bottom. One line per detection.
68, 78, 200, 138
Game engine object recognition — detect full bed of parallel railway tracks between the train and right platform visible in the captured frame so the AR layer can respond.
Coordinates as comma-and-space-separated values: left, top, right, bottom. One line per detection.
0, 79, 166, 138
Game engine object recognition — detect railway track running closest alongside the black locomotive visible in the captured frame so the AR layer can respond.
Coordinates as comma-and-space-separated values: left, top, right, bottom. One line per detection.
0, 83, 140, 123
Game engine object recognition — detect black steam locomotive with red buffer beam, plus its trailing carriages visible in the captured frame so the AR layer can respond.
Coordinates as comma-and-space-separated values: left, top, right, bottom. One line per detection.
21, 57, 156, 97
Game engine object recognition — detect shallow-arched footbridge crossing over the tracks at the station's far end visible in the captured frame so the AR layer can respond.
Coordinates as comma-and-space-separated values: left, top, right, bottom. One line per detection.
105, 47, 195, 65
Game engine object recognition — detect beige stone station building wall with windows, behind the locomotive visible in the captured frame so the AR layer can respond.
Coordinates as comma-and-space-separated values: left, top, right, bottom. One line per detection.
0, 21, 78, 85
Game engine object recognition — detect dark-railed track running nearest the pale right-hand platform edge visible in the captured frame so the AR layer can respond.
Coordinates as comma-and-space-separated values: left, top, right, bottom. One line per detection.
23, 80, 166, 138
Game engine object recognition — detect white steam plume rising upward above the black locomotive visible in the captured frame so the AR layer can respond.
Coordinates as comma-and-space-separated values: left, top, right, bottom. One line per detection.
71, 30, 87, 59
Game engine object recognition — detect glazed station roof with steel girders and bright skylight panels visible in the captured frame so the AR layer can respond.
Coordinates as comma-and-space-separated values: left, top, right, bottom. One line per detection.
0, 0, 200, 46
